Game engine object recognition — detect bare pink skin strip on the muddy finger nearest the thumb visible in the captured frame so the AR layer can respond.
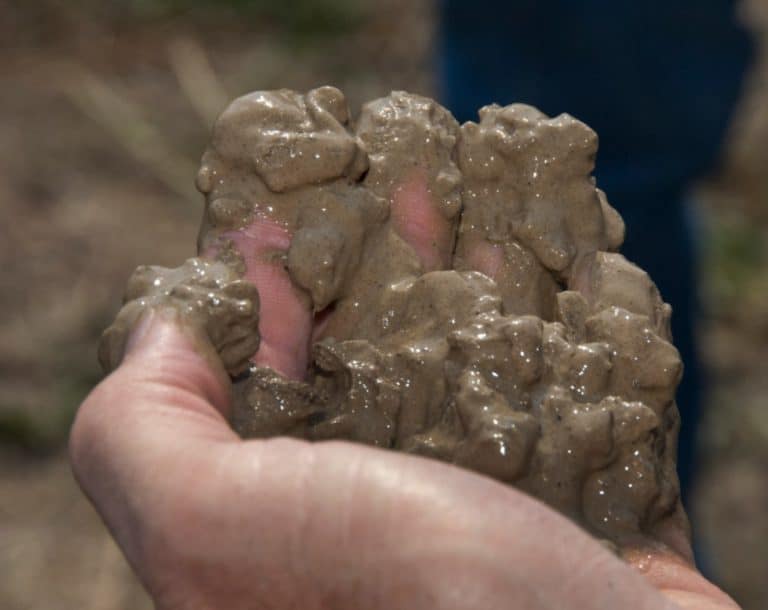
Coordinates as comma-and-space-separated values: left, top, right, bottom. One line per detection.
206, 218, 312, 379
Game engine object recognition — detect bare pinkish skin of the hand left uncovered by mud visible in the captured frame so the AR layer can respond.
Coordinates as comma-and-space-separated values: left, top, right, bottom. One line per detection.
70, 173, 738, 610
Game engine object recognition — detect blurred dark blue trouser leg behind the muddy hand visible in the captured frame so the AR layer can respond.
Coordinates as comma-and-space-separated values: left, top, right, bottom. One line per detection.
439, 0, 751, 510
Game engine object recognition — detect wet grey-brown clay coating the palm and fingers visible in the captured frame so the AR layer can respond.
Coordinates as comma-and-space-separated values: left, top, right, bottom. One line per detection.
100, 87, 682, 543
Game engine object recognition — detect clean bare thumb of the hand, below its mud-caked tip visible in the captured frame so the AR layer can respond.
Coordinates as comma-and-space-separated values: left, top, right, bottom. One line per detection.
69, 310, 238, 559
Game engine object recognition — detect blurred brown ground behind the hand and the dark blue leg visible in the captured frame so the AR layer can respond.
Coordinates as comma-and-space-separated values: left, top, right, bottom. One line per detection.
0, 0, 768, 610
